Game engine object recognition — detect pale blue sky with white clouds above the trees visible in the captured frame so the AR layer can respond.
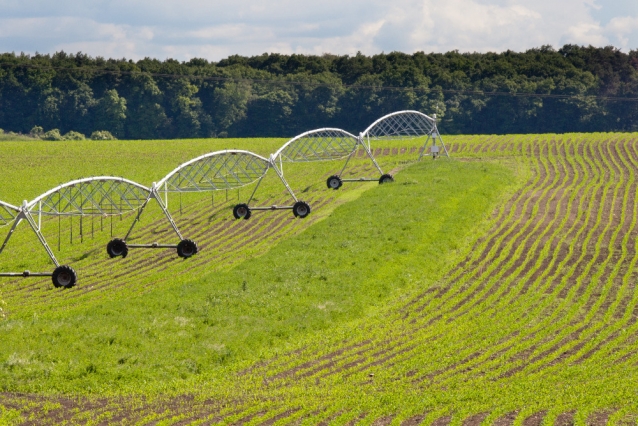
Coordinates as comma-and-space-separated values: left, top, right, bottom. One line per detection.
0, 0, 638, 61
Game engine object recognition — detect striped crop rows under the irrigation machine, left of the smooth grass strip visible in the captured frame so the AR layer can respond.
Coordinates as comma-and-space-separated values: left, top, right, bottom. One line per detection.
2, 146, 430, 316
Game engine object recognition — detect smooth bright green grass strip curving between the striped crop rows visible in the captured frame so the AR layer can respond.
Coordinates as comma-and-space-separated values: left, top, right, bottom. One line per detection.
0, 140, 513, 400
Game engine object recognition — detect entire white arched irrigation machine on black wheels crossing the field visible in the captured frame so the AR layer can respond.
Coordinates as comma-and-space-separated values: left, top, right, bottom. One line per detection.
0, 111, 449, 288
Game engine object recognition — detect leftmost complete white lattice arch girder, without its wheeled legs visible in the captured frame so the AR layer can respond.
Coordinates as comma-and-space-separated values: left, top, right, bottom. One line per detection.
28, 176, 150, 216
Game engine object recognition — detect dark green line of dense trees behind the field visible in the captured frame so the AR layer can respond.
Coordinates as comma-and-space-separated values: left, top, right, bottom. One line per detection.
0, 45, 638, 139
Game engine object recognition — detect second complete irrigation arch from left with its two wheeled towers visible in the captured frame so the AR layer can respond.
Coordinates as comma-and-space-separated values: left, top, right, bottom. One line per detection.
106, 150, 310, 258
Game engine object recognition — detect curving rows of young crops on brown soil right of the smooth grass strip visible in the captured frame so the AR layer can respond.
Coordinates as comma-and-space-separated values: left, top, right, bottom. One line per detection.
7, 135, 638, 425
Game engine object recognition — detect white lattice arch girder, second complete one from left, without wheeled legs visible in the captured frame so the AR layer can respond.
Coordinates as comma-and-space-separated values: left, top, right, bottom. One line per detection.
157, 150, 270, 192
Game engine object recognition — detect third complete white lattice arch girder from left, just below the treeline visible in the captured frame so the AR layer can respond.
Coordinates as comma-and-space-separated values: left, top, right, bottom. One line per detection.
273, 128, 359, 162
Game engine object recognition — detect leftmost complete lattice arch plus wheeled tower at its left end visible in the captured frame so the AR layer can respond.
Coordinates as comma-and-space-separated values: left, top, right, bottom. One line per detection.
0, 176, 150, 288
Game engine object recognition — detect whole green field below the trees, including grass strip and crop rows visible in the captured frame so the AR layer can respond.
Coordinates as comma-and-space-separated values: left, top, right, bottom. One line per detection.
0, 134, 638, 425
